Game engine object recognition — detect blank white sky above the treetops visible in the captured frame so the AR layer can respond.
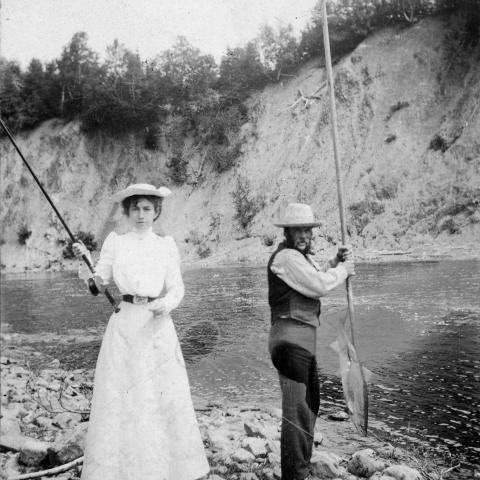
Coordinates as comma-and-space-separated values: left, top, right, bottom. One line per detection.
0, 0, 316, 68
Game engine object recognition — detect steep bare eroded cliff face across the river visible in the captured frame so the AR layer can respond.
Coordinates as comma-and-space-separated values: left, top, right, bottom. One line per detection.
0, 19, 480, 270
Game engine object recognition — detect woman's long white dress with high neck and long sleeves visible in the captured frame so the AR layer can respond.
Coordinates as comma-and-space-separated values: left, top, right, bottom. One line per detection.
82, 231, 209, 480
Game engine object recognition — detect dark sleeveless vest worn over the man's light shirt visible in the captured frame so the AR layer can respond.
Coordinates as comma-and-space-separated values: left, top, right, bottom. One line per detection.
268, 244, 321, 327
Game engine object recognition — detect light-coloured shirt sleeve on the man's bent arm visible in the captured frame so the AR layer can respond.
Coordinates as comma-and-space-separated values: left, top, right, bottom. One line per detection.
270, 248, 348, 298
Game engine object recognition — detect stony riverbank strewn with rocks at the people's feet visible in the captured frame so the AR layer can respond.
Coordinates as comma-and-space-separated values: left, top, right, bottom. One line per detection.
0, 347, 449, 480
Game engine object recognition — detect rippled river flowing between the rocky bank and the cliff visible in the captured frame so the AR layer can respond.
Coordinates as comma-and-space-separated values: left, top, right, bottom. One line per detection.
1, 261, 480, 472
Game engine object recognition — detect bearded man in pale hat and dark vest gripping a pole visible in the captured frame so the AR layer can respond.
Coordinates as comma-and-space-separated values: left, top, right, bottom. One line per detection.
268, 203, 355, 480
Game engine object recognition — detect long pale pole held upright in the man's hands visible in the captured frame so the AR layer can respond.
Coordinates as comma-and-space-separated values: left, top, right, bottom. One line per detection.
322, 0, 368, 435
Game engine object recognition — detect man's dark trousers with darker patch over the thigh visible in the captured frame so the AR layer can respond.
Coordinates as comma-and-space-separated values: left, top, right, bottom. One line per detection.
270, 318, 320, 480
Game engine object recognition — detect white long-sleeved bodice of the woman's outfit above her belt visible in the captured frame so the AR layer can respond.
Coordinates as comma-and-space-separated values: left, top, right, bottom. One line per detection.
95, 229, 185, 312
